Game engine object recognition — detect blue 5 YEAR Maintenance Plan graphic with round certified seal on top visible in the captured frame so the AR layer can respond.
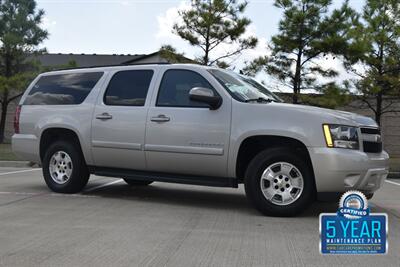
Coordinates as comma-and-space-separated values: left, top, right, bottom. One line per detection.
319, 191, 388, 254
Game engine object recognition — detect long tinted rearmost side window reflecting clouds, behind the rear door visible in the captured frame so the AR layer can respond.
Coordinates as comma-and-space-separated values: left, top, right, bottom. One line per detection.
24, 72, 103, 105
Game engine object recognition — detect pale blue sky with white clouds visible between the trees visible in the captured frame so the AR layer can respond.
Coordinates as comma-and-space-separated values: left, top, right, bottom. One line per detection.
37, 0, 364, 91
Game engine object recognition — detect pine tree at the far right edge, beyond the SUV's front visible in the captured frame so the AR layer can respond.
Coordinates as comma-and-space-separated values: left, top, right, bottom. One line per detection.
345, 0, 400, 125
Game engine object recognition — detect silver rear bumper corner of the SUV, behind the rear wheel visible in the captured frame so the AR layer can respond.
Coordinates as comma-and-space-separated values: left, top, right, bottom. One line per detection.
11, 134, 40, 163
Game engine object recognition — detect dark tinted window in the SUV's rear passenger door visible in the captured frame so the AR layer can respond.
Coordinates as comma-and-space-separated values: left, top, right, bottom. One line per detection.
104, 70, 153, 106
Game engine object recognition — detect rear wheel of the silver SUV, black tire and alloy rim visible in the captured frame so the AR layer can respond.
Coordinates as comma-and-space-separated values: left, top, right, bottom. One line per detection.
42, 141, 90, 194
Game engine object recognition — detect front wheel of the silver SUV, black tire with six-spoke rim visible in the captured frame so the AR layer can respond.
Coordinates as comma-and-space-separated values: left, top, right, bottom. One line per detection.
244, 148, 316, 217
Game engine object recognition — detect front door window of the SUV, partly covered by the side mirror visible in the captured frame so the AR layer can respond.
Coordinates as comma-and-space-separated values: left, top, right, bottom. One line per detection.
157, 70, 214, 107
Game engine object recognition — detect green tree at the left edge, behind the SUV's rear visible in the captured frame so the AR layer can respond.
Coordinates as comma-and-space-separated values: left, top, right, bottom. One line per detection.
0, 0, 47, 143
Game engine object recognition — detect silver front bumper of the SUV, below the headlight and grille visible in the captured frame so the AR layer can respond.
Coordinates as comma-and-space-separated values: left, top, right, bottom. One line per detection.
309, 148, 389, 193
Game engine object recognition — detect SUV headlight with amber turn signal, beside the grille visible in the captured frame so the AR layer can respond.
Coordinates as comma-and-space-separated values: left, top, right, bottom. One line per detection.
323, 124, 359, 149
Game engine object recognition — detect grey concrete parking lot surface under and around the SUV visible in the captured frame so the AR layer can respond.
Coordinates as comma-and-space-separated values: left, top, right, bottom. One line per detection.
0, 168, 400, 267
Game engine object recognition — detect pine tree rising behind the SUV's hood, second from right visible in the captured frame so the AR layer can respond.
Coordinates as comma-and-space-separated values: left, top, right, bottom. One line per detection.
244, 0, 358, 104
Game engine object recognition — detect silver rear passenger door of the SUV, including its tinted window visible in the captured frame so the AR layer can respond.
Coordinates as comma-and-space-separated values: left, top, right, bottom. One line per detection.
92, 68, 155, 170
